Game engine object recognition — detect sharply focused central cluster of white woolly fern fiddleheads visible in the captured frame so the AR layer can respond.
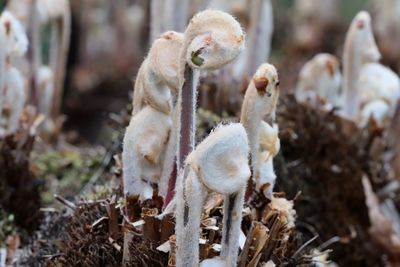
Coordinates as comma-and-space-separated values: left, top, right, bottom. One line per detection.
122, 10, 280, 266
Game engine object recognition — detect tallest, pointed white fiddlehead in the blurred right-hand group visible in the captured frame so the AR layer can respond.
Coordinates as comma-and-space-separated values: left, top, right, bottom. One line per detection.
343, 11, 381, 120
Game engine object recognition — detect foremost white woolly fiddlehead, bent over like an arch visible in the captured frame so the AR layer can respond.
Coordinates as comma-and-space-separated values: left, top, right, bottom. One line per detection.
175, 123, 250, 267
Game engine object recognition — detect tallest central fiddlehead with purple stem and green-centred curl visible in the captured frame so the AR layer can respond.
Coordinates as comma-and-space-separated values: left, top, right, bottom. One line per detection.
166, 10, 244, 206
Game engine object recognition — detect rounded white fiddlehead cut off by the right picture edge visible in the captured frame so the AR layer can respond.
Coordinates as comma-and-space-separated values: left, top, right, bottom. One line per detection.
357, 63, 400, 127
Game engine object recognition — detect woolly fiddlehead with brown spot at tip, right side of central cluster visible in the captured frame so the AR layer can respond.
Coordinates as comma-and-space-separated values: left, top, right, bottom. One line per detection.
240, 63, 279, 192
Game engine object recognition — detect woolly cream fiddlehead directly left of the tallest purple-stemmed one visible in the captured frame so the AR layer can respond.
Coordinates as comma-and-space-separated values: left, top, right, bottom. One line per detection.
132, 31, 183, 115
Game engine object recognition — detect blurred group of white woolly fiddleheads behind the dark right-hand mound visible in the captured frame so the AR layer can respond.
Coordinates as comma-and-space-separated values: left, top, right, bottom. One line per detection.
295, 11, 400, 127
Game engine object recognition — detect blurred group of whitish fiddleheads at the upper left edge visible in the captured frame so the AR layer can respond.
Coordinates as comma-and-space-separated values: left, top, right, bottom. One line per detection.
0, 0, 71, 136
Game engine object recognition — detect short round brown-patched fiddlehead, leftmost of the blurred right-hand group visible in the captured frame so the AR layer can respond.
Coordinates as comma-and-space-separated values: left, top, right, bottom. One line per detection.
295, 53, 342, 108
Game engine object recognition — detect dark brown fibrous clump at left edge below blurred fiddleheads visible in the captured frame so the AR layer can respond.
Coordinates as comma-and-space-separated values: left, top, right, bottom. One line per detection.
0, 108, 41, 232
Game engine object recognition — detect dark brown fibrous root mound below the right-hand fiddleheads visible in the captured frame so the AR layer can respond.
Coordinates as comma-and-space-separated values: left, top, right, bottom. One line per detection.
275, 96, 392, 266
